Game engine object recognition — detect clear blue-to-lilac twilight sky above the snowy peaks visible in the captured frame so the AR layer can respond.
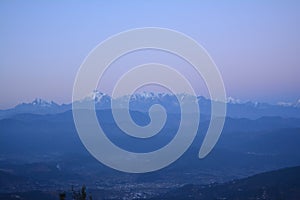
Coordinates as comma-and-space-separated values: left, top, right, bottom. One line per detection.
0, 0, 300, 109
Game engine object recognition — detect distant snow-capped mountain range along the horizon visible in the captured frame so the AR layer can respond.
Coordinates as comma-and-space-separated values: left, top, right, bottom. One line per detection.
0, 91, 300, 119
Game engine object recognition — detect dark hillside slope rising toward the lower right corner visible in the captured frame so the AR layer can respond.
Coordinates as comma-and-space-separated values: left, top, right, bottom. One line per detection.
153, 166, 300, 200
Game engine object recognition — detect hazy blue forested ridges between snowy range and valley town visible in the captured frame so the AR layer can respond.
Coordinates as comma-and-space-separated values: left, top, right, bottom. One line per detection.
0, 110, 300, 173
